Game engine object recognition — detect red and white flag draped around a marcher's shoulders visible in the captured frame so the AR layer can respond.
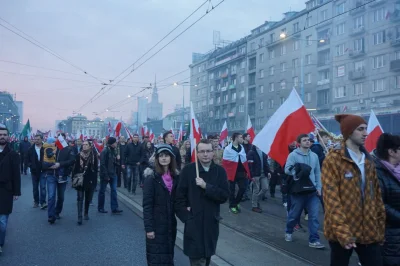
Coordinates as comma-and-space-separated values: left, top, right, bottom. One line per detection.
222, 143, 251, 181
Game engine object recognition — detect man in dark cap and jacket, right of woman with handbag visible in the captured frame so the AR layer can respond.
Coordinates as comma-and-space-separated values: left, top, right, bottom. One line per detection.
97, 137, 122, 214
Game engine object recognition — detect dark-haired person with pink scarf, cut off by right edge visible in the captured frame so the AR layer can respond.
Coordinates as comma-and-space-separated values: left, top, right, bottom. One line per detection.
372, 133, 400, 266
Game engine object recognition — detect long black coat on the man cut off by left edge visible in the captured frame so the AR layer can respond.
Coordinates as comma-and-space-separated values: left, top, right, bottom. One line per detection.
0, 144, 21, 215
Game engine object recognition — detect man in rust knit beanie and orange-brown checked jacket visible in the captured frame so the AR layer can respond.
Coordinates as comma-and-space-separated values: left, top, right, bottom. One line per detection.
322, 114, 386, 266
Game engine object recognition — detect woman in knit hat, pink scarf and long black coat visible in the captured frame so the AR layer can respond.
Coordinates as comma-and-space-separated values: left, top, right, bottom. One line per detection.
143, 144, 178, 266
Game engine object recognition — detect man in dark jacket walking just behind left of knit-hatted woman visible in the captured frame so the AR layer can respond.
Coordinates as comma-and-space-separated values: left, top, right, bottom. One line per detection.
122, 134, 144, 195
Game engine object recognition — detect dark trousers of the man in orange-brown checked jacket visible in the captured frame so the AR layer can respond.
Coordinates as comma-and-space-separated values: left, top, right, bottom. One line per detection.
329, 242, 383, 266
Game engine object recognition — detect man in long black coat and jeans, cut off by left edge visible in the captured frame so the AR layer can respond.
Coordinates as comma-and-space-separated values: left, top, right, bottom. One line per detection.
0, 128, 21, 255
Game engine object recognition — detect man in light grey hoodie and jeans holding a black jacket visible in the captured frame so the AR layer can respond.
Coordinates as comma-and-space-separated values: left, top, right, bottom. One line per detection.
285, 134, 325, 249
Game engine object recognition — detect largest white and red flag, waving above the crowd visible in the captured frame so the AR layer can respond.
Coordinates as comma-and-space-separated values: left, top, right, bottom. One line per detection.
253, 89, 315, 166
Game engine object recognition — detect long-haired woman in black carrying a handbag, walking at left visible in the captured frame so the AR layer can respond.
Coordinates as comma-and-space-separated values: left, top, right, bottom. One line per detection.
72, 140, 98, 225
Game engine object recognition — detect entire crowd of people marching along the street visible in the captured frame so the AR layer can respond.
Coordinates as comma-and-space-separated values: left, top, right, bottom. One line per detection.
0, 112, 400, 266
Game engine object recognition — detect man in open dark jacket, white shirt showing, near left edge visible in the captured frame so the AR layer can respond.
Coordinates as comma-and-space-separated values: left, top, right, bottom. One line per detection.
28, 134, 47, 209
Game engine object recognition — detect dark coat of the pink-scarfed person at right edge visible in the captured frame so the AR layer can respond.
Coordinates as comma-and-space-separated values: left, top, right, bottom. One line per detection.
373, 153, 400, 266
